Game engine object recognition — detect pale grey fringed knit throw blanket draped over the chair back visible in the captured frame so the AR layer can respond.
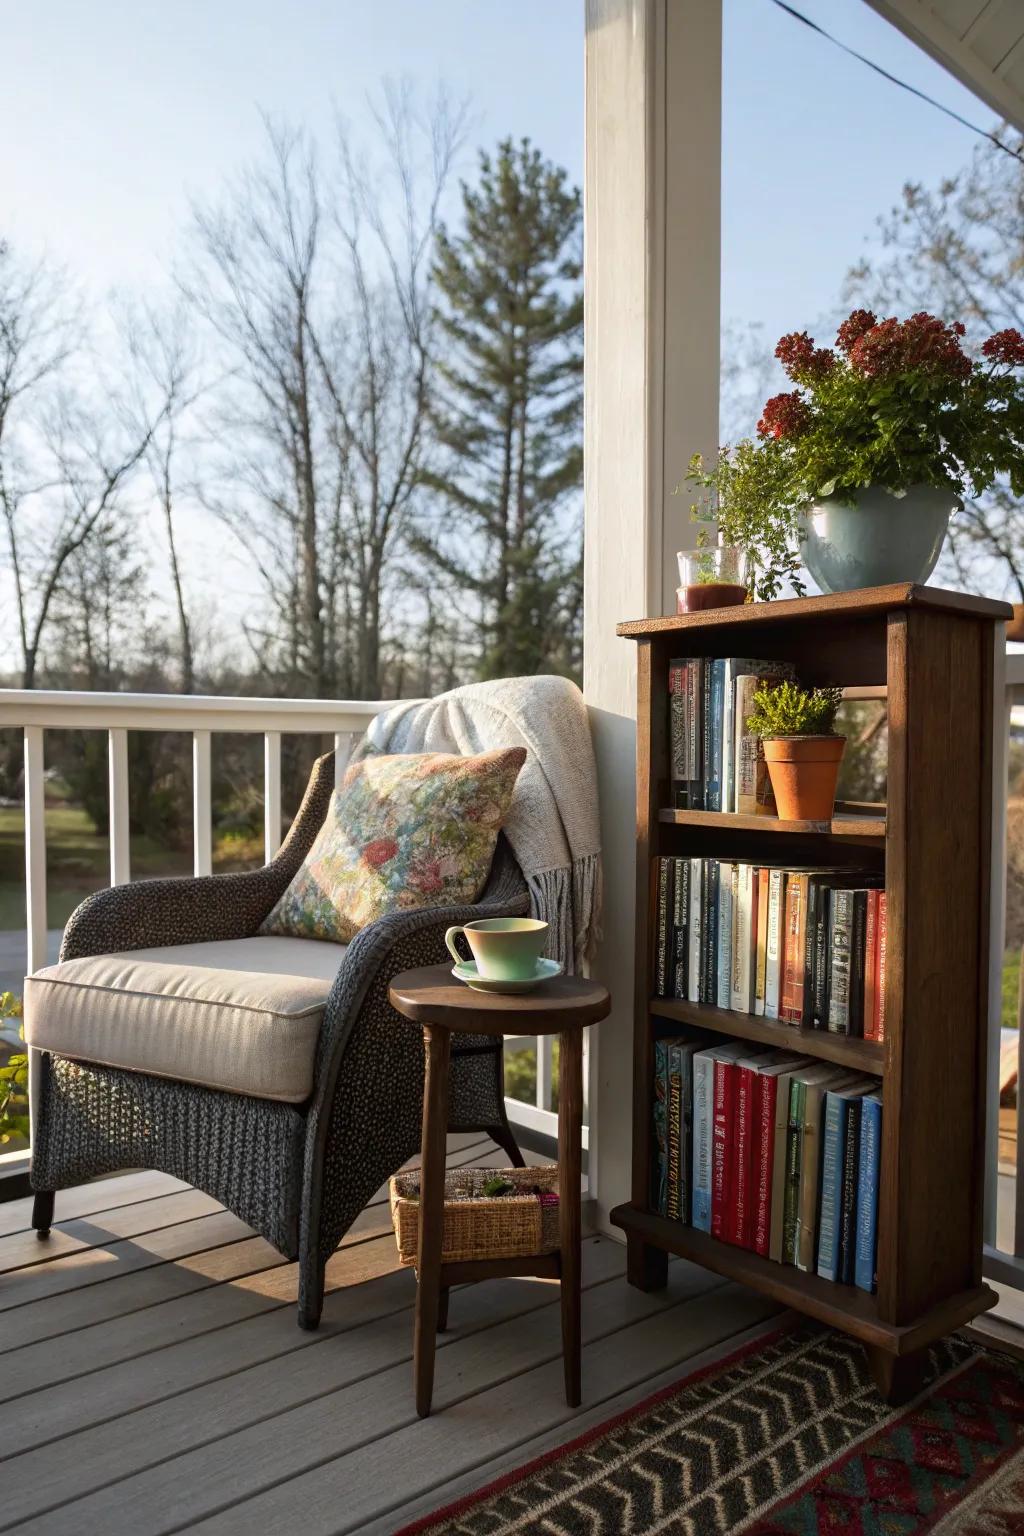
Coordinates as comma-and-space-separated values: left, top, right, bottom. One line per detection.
356, 677, 600, 975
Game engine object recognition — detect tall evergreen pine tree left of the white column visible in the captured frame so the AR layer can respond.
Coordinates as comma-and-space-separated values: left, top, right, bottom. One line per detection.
416, 138, 583, 677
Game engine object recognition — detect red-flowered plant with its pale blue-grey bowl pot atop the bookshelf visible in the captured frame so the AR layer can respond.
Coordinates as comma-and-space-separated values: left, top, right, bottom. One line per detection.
757, 309, 1024, 591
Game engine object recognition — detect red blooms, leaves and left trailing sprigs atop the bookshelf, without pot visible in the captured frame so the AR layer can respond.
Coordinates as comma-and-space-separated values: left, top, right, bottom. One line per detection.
688, 309, 1024, 599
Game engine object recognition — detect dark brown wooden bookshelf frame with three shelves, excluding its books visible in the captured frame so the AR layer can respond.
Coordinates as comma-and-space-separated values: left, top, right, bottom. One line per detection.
613, 585, 1010, 1401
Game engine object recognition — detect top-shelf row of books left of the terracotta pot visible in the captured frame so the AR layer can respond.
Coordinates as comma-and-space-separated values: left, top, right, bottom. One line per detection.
668, 656, 795, 816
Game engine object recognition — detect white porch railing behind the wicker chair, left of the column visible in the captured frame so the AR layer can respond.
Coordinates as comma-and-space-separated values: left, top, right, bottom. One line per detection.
0, 688, 568, 1146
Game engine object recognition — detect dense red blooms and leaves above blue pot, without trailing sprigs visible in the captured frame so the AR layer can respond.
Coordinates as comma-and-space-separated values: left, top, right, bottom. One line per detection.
757, 309, 1024, 508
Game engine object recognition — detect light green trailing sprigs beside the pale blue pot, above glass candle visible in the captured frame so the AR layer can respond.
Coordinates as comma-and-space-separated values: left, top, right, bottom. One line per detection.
686, 438, 804, 602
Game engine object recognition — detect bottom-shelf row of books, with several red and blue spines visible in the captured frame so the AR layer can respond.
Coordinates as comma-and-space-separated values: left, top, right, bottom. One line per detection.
651, 1037, 881, 1292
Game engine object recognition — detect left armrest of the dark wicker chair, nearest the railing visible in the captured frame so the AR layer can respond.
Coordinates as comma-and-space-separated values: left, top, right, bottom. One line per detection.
60, 753, 335, 960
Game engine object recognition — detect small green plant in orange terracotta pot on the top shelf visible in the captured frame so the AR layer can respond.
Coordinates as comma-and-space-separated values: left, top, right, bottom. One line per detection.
746, 682, 846, 822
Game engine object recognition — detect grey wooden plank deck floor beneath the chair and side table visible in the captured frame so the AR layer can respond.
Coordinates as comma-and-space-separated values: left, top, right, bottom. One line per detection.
0, 1137, 772, 1536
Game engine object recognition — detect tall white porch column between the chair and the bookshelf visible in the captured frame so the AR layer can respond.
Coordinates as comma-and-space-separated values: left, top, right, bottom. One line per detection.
583, 0, 722, 1229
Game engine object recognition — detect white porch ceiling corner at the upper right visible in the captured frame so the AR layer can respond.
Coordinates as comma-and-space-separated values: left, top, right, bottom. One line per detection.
867, 0, 1024, 132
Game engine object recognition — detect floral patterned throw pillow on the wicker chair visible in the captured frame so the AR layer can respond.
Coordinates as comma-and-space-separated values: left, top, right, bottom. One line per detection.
261, 746, 527, 945
